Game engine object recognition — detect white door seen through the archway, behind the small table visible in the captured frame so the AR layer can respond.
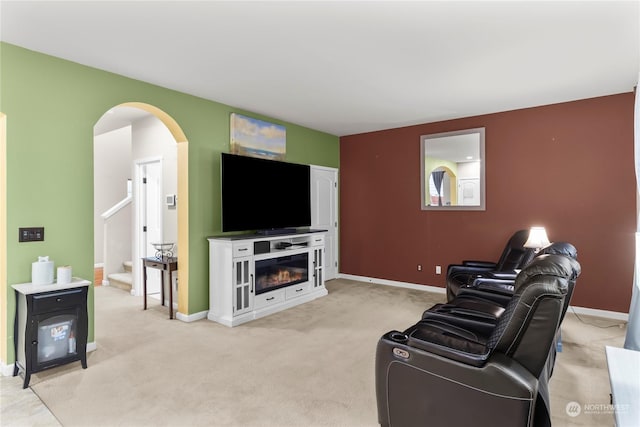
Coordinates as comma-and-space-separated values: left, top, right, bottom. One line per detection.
140, 160, 162, 295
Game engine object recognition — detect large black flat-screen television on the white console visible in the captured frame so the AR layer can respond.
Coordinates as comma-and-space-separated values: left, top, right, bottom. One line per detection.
220, 153, 311, 231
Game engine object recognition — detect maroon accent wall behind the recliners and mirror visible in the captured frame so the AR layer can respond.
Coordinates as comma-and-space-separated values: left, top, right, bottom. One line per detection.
340, 92, 636, 312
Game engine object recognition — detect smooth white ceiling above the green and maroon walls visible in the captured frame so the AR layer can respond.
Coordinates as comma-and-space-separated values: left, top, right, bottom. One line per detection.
0, 0, 640, 136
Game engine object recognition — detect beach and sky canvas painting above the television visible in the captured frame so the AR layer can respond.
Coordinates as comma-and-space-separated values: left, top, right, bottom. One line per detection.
229, 113, 287, 160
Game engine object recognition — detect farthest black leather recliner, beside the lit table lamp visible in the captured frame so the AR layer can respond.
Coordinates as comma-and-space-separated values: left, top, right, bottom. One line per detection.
447, 230, 535, 301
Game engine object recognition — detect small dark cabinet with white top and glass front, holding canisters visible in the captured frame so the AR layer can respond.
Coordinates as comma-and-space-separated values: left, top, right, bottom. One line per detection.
13, 278, 90, 388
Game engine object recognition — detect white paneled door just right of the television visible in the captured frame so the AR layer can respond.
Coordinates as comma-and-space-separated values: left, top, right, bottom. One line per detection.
311, 166, 338, 280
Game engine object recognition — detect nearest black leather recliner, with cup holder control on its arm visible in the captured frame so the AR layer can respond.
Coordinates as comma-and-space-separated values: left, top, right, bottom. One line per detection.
375, 255, 579, 427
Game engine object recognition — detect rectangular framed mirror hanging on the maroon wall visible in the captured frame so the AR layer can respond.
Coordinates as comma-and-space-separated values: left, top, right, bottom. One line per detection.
420, 128, 485, 211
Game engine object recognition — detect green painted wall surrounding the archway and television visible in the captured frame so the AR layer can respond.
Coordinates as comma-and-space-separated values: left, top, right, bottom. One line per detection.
0, 43, 339, 363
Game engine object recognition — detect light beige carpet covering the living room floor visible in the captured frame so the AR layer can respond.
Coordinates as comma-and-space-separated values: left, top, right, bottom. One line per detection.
26, 279, 624, 427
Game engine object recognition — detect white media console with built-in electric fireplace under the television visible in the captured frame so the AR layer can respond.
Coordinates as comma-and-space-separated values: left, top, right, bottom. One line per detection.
207, 230, 327, 326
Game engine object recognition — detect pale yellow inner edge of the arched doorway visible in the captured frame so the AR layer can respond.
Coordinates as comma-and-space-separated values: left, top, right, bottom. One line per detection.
95, 102, 189, 320
